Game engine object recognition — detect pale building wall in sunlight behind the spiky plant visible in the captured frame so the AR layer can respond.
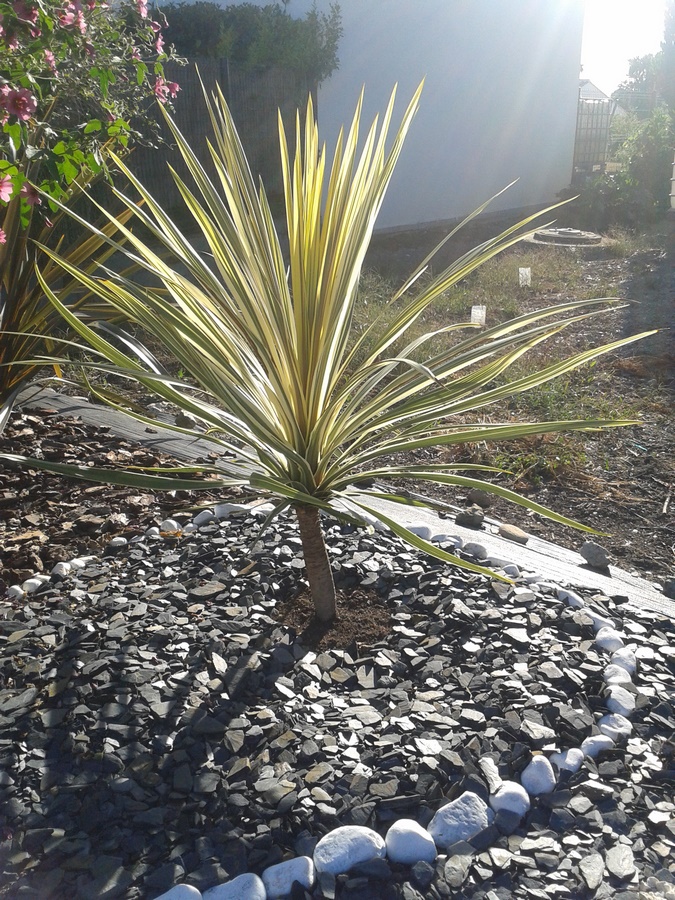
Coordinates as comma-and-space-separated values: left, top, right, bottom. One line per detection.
234, 0, 583, 228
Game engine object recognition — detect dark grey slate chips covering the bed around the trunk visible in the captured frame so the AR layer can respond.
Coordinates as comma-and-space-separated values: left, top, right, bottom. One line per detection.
0, 412, 675, 900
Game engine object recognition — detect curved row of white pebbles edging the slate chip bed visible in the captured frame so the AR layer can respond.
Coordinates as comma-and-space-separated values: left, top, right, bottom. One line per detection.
2, 503, 675, 900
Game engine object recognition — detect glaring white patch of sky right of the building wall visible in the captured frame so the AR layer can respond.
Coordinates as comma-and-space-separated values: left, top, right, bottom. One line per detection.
581, 0, 666, 94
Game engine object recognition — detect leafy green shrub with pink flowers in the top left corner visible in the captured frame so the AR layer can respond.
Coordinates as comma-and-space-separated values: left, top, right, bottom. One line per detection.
0, 0, 179, 242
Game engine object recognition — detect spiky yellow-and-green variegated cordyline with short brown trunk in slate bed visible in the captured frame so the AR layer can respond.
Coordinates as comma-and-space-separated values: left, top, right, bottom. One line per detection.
3, 86, 656, 622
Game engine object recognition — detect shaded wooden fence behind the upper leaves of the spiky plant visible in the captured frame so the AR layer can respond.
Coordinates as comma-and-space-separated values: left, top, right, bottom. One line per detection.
130, 59, 315, 209
